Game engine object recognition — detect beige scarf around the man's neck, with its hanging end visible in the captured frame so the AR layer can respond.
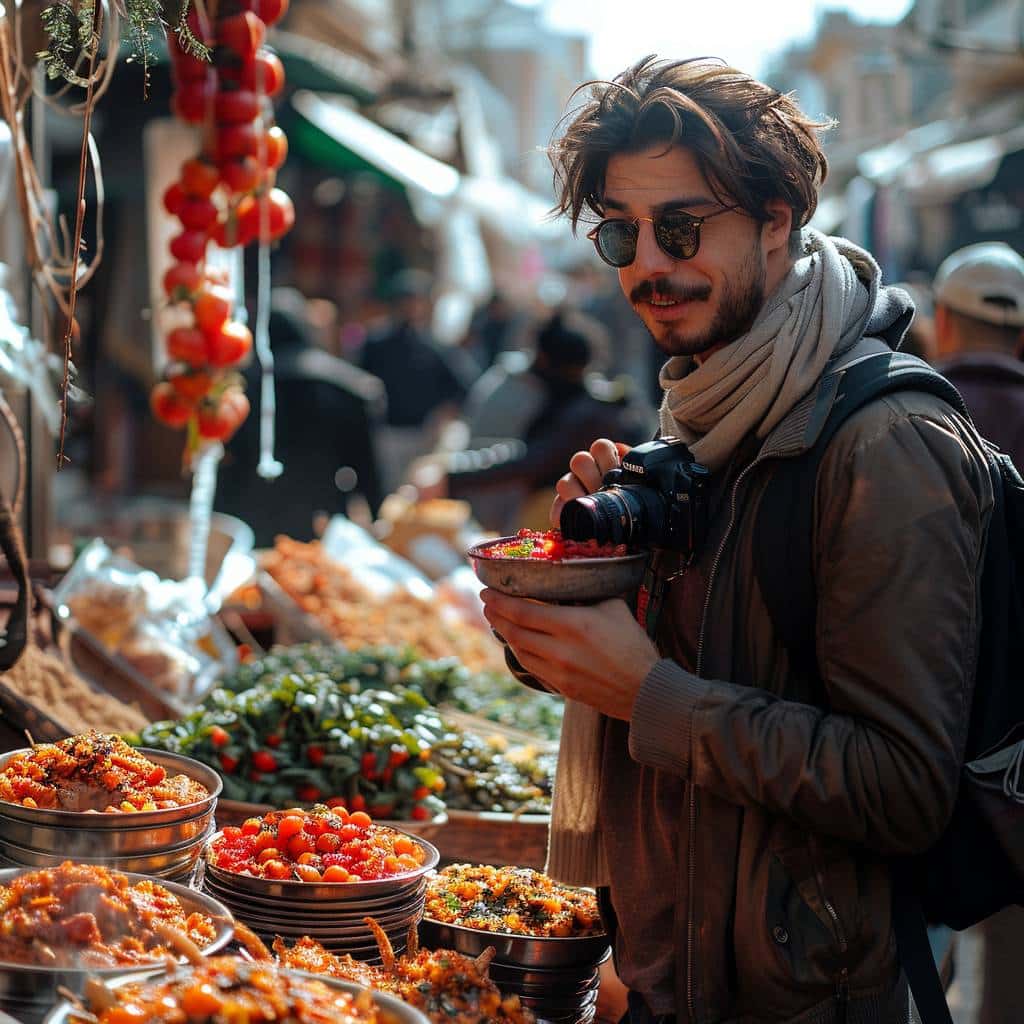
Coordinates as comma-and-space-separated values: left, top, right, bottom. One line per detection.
547, 228, 908, 886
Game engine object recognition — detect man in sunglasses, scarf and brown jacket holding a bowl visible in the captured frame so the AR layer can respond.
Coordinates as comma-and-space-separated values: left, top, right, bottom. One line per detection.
484, 58, 992, 1024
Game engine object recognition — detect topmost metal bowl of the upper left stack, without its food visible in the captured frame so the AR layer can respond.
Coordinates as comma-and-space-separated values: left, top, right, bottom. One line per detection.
0, 746, 224, 827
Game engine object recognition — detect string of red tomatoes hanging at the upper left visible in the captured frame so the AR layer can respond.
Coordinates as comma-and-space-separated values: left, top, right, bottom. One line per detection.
151, 0, 295, 461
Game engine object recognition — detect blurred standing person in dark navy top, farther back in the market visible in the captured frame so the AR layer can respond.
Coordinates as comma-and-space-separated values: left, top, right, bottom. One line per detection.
357, 269, 469, 494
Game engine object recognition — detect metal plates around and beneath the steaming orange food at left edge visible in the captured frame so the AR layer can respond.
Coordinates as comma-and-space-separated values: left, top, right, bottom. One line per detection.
0, 868, 234, 1024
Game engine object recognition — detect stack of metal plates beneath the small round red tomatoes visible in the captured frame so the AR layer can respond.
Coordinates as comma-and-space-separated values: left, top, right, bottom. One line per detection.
202, 833, 440, 961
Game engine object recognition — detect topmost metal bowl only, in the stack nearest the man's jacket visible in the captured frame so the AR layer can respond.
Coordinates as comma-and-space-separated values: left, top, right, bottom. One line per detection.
420, 918, 608, 968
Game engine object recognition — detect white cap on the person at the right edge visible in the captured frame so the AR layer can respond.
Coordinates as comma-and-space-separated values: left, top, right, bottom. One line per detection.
934, 242, 1024, 327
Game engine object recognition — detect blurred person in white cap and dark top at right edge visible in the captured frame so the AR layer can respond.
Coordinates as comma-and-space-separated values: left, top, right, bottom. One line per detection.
934, 242, 1024, 464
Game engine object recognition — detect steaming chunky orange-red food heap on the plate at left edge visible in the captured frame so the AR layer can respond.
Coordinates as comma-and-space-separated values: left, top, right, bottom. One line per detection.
0, 861, 217, 968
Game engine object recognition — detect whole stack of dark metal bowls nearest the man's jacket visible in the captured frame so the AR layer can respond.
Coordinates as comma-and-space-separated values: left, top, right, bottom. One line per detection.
420, 919, 611, 1024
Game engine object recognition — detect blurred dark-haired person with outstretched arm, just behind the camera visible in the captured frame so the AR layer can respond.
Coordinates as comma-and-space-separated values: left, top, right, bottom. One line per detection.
413, 309, 654, 531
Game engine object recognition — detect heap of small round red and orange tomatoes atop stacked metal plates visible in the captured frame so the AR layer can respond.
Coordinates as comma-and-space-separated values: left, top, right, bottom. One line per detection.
209, 804, 427, 883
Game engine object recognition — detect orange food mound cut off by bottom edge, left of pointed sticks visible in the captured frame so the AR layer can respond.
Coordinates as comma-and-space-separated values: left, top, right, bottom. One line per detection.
72, 956, 396, 1024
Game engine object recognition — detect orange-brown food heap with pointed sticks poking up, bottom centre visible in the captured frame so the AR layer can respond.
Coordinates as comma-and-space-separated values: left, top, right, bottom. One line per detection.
273, 918, 534, 1024
